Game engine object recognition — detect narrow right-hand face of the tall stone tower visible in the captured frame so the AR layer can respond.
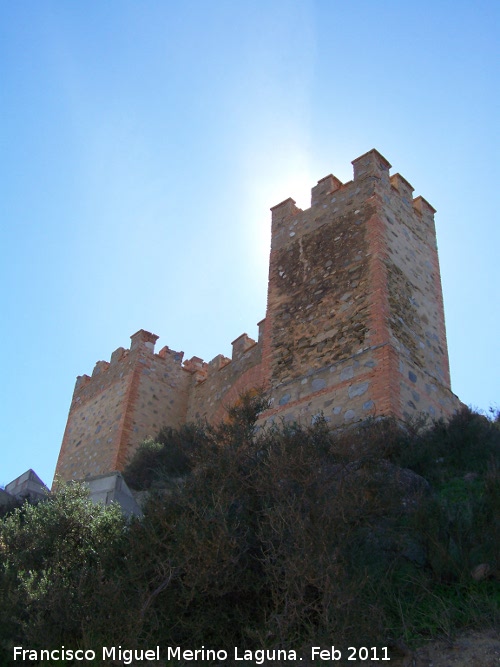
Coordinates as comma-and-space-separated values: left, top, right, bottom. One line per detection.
382, 174, 459, 419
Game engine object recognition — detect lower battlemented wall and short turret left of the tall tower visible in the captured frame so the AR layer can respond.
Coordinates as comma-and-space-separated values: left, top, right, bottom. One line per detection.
56, 321, 264, 480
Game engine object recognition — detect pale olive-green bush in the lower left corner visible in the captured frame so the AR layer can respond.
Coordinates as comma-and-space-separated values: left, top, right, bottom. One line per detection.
0, 484, 135, 657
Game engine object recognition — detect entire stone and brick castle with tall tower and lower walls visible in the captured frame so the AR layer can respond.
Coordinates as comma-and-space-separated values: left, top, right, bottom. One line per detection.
56, 150, 461, 480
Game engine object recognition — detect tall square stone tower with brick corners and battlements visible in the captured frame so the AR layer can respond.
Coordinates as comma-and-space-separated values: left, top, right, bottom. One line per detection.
264, 150, 459, 425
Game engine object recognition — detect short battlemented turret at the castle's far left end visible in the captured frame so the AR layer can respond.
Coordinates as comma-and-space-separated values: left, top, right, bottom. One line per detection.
56, 331, 192, 480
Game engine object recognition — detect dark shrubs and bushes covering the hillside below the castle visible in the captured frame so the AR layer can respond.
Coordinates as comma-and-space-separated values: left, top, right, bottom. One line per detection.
0, 395, 500, 659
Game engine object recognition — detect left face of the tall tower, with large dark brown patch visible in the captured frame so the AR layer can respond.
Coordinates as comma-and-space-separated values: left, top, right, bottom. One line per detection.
267, 159, 377, 423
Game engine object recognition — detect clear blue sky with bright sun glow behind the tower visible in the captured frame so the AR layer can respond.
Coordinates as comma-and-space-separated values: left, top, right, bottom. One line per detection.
0, 0, 500, 485
